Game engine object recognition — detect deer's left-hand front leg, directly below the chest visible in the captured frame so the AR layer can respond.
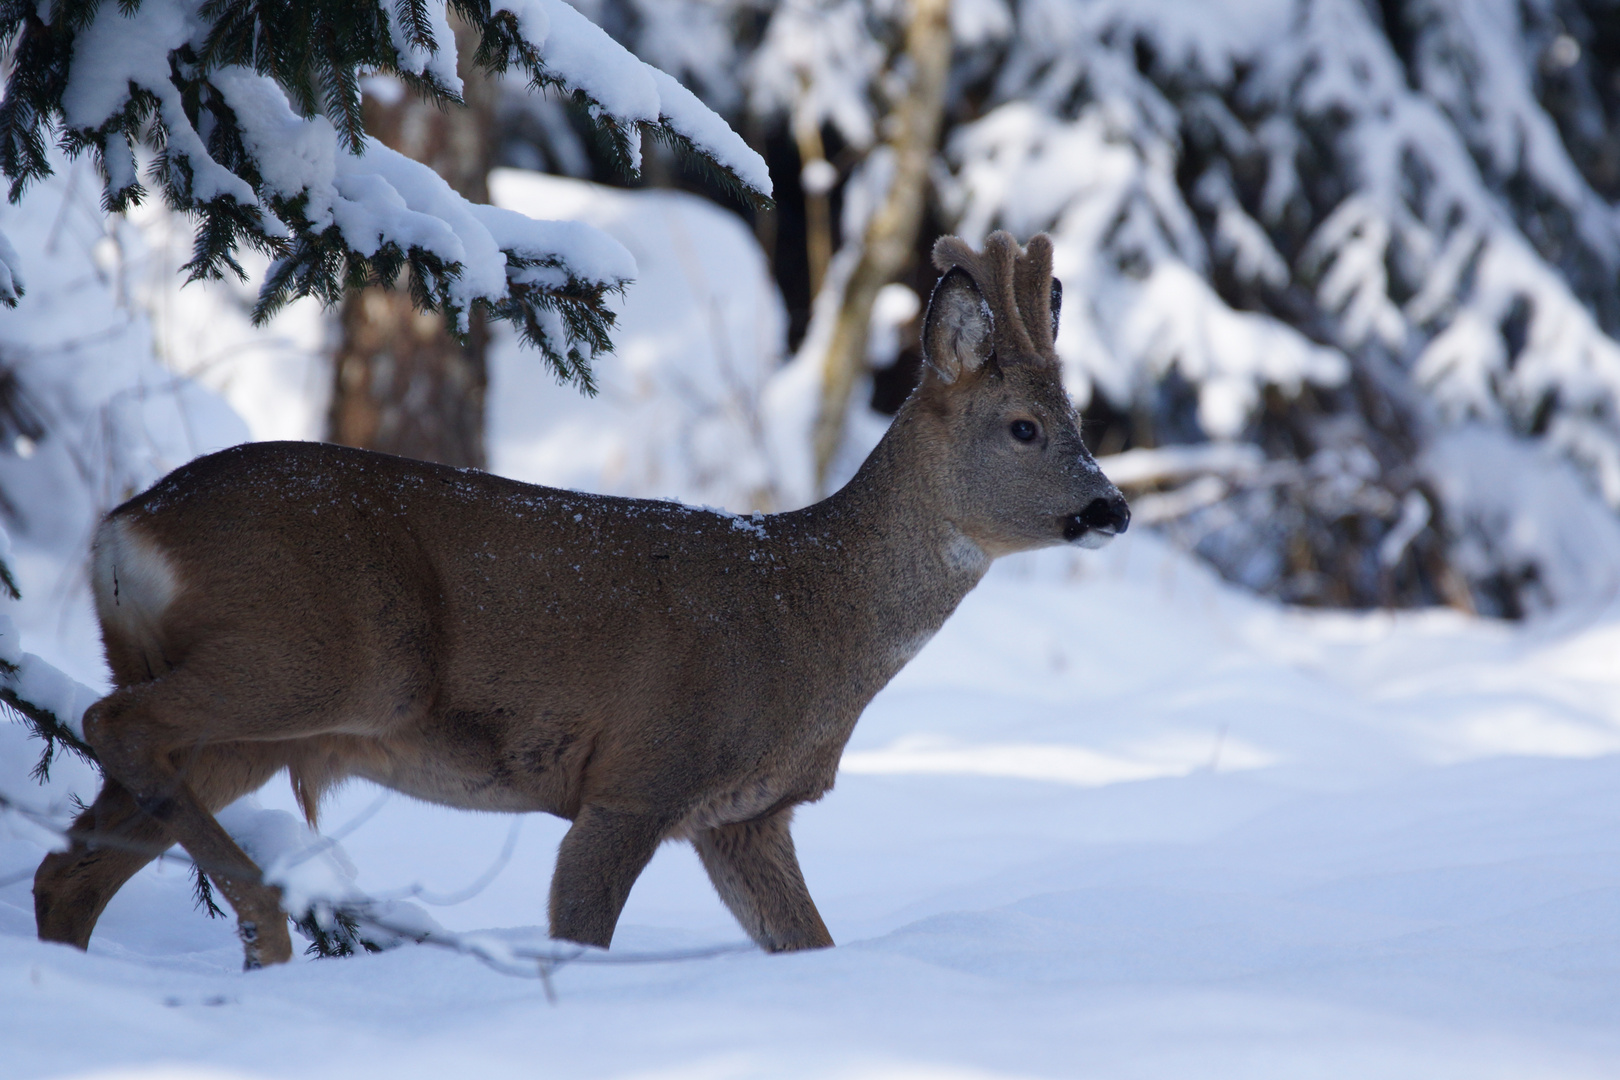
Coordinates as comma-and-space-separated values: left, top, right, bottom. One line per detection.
551, 805, 669, 949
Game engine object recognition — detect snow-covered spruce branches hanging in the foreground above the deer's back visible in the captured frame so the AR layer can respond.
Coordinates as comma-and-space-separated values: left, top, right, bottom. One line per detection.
0, 0, 771, 389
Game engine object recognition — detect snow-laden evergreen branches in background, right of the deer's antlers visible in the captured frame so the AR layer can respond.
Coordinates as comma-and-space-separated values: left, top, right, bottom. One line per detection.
913, 0, 1620, 612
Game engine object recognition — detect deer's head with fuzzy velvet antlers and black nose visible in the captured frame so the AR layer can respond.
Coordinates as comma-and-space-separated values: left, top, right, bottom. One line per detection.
917, 232, 1131, 555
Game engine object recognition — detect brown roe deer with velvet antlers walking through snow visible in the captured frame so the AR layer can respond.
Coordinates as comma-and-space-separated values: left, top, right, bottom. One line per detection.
34, 233, 1129, 967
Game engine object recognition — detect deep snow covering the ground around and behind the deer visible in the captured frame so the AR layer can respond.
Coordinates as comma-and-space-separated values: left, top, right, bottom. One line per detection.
0, 178, 1620, 1080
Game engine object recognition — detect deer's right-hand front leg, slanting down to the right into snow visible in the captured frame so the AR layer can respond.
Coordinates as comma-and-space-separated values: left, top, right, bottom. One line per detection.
692, 808, 833, 952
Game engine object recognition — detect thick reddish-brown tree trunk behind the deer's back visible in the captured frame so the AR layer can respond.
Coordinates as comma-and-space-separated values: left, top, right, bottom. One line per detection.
327, 16, 496, 468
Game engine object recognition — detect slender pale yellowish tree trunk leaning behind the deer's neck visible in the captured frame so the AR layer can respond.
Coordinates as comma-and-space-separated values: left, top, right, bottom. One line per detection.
815, 0, 951, 492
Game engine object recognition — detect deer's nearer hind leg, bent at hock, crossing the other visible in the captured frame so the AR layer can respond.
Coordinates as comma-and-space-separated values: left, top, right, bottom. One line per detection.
78, 677, 292, 968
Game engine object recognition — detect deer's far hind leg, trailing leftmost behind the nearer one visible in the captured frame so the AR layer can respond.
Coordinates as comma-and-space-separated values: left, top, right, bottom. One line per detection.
34, 743, 285, 949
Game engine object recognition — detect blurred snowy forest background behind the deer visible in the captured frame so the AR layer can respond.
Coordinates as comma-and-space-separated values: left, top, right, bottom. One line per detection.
0, 0, 1620, 634
